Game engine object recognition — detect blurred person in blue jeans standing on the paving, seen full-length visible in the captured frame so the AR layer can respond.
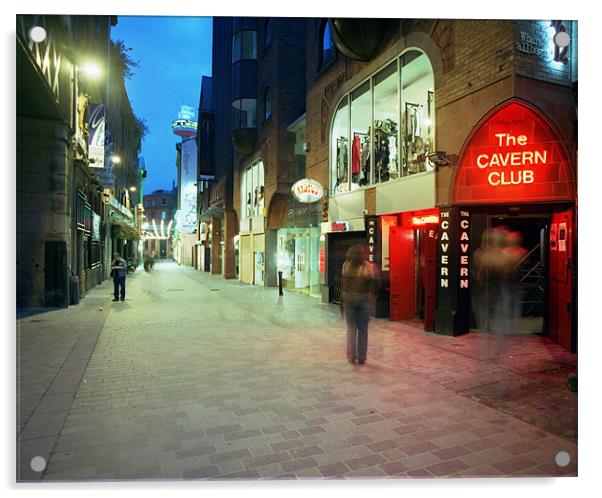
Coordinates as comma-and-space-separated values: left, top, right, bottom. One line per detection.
342, 245, 376, 364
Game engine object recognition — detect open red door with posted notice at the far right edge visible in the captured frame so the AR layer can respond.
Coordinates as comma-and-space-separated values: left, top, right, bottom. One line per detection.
548, 211, 573, 350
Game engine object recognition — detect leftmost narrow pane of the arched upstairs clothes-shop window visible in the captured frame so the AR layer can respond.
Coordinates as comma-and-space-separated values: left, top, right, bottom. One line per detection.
330, 97, 351, 193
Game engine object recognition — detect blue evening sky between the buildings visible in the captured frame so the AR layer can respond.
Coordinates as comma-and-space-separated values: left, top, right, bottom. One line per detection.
111, 16, 212, 193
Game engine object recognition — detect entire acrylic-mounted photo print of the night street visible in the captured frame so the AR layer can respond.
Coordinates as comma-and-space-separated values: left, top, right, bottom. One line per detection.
15, 14, 578, 483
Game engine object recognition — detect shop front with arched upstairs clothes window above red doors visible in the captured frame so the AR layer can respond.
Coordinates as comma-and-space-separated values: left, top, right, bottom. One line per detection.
322, 48, 437, 320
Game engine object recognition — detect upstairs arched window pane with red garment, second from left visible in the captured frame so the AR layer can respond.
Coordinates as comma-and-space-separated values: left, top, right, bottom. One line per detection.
351, 81, 373, 190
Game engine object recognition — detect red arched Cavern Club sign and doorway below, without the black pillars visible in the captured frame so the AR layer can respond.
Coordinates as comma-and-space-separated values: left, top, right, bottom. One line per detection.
451, 99, 576, 350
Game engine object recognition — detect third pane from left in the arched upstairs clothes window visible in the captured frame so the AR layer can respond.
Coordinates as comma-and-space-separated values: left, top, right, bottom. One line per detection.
373, 61, 399, 183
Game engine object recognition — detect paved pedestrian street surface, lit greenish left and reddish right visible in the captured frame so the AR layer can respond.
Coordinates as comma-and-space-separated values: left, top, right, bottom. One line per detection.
17, 263, 577, 481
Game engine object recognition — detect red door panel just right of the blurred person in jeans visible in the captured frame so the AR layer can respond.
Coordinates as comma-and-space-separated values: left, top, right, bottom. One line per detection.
389, 227, 416, 320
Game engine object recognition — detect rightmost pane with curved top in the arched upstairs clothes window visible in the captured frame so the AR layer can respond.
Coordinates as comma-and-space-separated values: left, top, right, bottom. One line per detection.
401, 51, 435, 176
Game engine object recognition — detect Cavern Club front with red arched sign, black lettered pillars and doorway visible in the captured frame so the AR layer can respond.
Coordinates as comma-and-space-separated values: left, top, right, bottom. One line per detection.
436, 99, 577, 351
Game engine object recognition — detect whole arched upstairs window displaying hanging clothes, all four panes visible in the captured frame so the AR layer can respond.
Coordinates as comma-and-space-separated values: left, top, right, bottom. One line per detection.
330, 50, 435, 195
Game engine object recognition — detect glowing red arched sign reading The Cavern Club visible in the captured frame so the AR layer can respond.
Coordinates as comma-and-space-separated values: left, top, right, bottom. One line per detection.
452, 100, 574, 205
